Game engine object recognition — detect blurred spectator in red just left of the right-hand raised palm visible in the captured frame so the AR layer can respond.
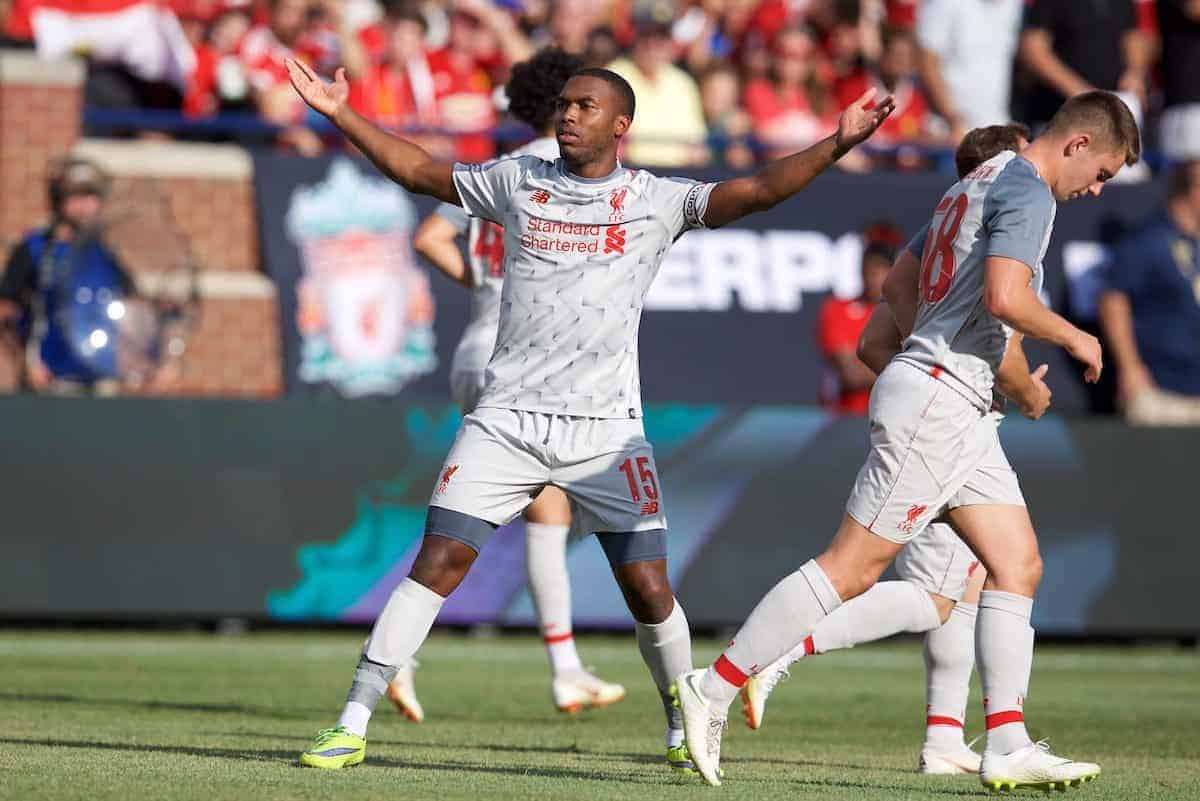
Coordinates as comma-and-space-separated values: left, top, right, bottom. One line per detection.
744, 25, 838, 158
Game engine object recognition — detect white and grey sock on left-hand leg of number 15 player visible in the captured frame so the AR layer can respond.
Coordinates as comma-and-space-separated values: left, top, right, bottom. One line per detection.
337, 578, 445, 737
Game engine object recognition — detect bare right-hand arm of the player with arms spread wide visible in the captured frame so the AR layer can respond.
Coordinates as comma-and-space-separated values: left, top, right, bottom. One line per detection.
704, 89, 895, 228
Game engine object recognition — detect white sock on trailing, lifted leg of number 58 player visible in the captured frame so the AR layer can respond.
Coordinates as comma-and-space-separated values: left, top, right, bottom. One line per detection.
700, 560, 841, 715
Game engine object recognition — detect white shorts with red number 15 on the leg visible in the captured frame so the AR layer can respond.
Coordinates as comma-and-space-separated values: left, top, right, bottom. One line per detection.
430, 406, 667, 532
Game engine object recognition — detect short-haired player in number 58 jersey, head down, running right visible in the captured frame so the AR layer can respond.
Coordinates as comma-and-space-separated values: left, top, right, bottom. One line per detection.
678, 91, 1141, 789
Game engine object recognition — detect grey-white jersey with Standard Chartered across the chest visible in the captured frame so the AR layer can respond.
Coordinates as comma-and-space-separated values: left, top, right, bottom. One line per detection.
454, 156, 713, 417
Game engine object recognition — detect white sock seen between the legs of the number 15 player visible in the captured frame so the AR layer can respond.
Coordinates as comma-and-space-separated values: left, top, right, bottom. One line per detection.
526, 523, 583, 676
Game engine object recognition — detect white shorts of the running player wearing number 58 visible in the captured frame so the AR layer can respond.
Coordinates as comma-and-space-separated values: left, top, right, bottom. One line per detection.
846, 361, 1025, 544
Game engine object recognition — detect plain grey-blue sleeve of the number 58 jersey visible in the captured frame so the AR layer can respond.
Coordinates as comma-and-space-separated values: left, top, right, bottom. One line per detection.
983, 162, 1054, 271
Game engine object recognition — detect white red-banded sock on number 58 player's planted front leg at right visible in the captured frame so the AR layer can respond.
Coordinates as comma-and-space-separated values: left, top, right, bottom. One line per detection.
976, 590, 1033, 754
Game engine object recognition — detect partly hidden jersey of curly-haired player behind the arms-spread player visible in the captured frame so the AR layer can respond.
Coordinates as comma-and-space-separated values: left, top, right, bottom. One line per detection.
434, 137, 558, 373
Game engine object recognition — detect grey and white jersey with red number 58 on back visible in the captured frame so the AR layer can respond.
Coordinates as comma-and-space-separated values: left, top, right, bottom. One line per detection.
896, 150, 1056, 410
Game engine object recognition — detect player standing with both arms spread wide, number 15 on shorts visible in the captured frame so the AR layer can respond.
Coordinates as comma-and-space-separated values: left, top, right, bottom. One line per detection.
288, 53, 894, 770
